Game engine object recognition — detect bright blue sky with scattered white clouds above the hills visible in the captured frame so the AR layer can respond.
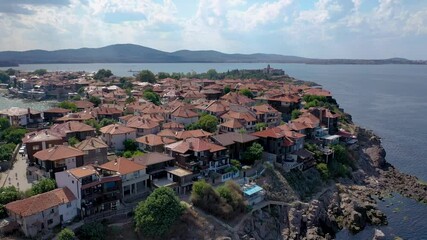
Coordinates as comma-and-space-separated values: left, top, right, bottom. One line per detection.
0, 0, 427, 60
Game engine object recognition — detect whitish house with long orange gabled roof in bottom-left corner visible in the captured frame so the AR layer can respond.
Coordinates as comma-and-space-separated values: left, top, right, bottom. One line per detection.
5, 187, 77, 238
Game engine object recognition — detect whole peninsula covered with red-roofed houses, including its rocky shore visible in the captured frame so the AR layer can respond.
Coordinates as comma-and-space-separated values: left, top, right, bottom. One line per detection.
0, 66, 427, 239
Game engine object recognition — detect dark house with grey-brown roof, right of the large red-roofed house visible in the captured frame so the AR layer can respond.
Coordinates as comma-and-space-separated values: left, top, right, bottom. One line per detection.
211, 132, 258, 160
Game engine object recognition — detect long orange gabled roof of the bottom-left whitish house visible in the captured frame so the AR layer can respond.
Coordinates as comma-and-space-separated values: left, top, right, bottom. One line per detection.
5, 187, 76, 217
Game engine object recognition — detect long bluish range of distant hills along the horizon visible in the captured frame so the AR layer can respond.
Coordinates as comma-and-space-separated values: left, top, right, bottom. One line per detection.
0, 44, 427, 66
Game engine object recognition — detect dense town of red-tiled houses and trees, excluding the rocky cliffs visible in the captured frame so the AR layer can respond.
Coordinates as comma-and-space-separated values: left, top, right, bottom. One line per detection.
0, 66, 357, 238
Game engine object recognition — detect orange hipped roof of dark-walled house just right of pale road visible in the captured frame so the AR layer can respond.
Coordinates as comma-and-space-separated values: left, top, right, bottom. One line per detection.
34, 145, 84, 161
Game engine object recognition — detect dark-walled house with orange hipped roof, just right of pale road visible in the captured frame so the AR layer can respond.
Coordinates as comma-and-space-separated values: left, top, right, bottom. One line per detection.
34, 145, 84, 178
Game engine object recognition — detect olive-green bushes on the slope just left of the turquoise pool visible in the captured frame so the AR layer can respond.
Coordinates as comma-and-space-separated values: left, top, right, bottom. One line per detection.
191, 180, 246, 220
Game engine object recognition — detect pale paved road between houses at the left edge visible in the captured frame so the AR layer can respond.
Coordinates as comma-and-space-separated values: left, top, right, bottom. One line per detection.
0, 154, 33, 191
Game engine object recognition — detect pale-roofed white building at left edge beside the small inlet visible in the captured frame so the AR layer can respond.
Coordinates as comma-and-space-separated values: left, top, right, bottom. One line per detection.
0, 107, 43, 126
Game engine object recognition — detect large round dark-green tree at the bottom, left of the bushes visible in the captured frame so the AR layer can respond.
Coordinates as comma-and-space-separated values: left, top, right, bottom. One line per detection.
134, 187, 184, 237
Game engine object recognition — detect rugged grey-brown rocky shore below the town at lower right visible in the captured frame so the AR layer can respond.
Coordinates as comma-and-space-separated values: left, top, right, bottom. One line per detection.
238, 127, 427, 240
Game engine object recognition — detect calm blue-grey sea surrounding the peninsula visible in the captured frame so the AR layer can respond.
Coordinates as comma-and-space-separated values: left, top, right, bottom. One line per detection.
0, 63, 427, 239
